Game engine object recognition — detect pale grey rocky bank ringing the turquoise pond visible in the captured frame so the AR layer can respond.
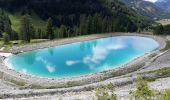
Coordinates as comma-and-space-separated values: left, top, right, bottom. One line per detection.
0, 33, 169, 98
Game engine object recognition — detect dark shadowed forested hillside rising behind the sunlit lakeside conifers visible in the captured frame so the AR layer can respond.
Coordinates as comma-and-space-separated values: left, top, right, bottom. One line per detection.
0, 0, 149, 30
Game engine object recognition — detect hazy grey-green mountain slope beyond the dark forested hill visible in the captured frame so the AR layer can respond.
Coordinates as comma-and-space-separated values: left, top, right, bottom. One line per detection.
120, 0, 170, 19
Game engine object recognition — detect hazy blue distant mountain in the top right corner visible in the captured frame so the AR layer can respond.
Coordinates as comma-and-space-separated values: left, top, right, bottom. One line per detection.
155, 0, 170, 12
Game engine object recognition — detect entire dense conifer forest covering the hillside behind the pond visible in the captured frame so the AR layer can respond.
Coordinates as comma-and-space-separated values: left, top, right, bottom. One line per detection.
0, 0, 150, 42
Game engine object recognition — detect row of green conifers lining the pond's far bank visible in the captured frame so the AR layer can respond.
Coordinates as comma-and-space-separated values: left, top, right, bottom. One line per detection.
0, 11, 138, 43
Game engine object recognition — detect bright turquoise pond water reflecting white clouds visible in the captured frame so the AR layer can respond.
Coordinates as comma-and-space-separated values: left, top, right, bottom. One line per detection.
6, 36, 159, 78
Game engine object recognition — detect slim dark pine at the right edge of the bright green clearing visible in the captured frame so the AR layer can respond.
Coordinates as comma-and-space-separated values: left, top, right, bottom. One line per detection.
46, 18, 54, 40
